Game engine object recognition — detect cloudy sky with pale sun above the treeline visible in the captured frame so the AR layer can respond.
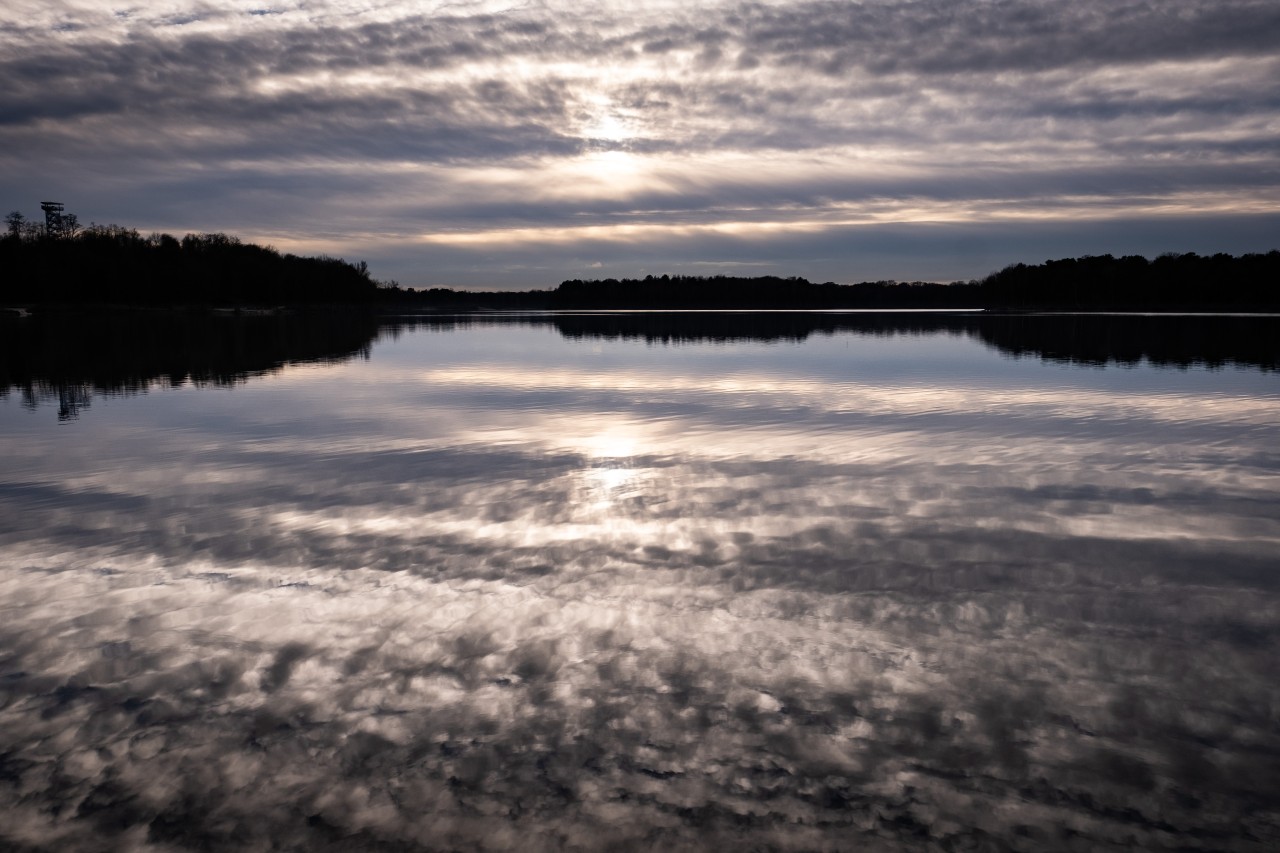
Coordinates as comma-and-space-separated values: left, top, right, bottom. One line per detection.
0, 0, 1280, 289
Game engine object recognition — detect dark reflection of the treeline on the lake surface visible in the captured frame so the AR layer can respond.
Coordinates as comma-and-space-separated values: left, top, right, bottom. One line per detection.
0, 311, 1280, 420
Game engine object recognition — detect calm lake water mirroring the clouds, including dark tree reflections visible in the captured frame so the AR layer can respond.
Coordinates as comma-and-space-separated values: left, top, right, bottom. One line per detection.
0, 315, 1280, 850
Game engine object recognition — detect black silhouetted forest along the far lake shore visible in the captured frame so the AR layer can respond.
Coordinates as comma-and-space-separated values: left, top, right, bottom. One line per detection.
0, 211, 1280, 311
